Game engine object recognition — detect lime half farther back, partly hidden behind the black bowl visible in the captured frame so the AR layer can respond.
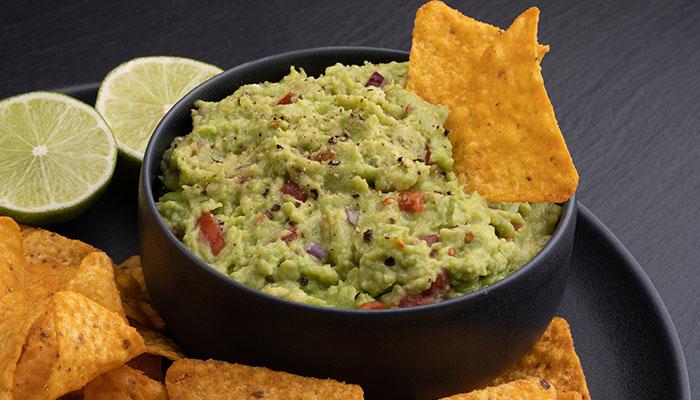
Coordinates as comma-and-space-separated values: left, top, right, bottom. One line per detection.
95, 56, 222, 164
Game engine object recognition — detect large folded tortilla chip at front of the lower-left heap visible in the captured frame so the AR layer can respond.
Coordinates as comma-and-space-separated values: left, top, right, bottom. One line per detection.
13, 291, 144, 400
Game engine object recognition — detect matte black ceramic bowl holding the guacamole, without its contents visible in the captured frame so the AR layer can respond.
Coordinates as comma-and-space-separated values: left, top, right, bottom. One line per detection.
139, 47, 576, 399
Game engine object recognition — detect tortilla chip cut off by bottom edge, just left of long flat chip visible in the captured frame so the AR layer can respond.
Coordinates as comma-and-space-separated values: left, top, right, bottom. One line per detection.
83, 365, 168, 400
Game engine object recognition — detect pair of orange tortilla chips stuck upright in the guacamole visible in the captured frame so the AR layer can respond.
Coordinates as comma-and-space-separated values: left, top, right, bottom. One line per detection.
406, 1, 578, 203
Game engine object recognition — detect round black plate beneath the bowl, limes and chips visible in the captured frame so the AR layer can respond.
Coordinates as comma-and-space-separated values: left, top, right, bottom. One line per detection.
54, 84, 690, 400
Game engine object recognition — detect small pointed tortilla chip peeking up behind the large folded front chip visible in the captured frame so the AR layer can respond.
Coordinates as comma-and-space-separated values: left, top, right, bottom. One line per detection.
63, 252, 125, 317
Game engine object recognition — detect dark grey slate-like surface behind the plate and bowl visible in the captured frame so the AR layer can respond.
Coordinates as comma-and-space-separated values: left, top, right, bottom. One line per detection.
0, 0, 700, 392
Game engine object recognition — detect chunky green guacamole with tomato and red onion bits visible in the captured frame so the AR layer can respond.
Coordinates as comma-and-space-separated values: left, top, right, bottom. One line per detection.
157, 62, 561, 309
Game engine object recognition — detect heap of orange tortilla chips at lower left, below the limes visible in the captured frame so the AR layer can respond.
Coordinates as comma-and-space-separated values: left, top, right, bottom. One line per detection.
0, 217, 184, 400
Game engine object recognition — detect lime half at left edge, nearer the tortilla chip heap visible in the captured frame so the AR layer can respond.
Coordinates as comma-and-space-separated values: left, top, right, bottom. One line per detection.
0, 92, 117, 225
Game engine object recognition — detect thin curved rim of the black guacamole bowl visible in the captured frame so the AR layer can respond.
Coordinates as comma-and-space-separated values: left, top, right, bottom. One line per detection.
139, 46, 577, 318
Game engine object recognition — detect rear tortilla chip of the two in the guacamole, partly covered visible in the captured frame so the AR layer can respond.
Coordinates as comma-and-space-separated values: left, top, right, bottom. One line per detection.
406, 1, 549, 109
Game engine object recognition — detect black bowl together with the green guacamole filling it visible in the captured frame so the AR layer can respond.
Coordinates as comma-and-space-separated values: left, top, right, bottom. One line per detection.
139, 48, 575, 398
